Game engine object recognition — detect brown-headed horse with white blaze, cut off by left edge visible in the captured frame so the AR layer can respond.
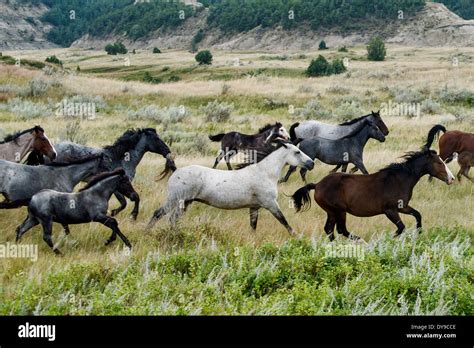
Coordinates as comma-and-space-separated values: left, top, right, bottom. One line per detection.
0, 126, 57, 163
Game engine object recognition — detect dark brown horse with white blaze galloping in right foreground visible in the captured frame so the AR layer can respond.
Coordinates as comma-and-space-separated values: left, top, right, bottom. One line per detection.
292, 149, 454, 241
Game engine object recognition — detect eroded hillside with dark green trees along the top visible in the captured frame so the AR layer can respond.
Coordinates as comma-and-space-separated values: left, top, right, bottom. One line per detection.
0, 0, 474, 51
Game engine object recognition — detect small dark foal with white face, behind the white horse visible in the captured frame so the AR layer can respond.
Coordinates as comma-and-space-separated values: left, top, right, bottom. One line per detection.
209, 122, 290, 170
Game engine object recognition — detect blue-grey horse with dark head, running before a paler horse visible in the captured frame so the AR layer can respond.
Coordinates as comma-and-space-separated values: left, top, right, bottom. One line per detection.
280, 119, 385, 182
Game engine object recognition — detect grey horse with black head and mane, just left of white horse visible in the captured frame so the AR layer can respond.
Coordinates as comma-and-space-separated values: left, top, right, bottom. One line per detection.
28, 128, 176, 220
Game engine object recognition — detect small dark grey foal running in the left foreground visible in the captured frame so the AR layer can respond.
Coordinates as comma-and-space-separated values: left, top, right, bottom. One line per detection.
16, 168, 136, 254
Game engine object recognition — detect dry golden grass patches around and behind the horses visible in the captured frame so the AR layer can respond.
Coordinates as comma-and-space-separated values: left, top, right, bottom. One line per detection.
0, 47, 474, 314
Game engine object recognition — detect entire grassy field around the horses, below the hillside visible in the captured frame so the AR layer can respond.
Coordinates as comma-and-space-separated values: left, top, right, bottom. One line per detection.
0, 46, 474, 315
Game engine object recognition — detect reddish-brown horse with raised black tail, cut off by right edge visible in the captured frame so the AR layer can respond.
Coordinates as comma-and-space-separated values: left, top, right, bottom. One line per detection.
425, 124, 474, 163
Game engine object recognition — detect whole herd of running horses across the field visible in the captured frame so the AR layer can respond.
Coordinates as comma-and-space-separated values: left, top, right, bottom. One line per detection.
0, 112, 474, 254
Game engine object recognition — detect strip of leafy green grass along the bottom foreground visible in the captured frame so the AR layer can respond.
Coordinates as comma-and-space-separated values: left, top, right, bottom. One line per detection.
0, 227, 474, 315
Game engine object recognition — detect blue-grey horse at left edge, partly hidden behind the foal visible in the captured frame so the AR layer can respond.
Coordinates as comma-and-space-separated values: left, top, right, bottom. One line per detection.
0, 155, 103, 209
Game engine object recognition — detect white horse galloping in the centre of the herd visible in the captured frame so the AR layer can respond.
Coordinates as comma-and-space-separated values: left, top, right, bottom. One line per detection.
148, 142, 314, 235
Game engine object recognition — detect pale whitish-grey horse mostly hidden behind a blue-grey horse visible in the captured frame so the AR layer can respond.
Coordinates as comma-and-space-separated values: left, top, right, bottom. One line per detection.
290, 111, 389, 142
